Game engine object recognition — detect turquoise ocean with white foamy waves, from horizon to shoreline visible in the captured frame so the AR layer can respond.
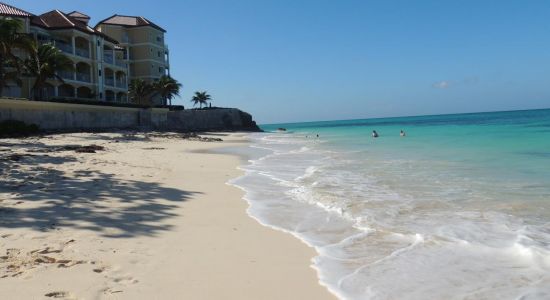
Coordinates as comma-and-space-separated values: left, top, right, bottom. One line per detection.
231, 110, 550, 299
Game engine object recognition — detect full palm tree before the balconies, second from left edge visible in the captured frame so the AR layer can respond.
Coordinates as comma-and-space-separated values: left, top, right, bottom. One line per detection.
25, 43, 74, 100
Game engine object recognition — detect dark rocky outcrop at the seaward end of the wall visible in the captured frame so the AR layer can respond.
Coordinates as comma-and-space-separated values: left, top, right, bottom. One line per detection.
168, 108, 261, 131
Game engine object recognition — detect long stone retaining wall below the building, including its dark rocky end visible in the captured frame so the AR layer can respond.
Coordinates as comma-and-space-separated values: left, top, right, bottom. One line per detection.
0, 98, 259, 131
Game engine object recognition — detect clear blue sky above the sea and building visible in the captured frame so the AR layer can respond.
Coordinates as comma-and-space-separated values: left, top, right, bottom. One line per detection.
11, 0, 550, 123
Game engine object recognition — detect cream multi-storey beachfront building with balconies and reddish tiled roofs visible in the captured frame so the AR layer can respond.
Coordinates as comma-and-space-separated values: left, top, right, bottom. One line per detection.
0, 2, 170, 103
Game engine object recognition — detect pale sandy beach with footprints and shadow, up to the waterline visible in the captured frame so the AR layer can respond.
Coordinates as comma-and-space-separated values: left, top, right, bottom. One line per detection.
0, 133, 334, 299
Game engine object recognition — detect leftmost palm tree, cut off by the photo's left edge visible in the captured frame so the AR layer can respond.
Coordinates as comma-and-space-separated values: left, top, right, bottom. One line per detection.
0, 18, 32, 95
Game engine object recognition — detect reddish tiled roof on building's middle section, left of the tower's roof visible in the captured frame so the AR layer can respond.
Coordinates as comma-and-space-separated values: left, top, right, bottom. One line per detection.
31, 9, 118, 44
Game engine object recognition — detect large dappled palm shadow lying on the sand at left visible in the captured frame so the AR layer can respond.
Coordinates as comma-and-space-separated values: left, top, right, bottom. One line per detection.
0, 144, 199, 237
